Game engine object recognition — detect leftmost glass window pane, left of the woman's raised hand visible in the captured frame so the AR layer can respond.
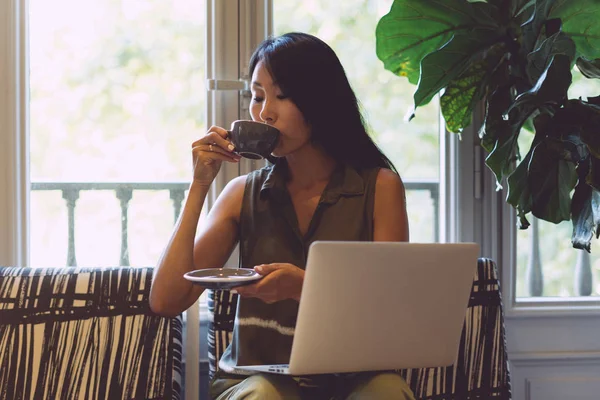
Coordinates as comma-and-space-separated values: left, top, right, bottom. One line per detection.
29, 0, 206, 266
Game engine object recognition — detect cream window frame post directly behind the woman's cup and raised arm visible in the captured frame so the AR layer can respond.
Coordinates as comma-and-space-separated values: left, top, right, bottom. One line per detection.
196, 0, 273, 399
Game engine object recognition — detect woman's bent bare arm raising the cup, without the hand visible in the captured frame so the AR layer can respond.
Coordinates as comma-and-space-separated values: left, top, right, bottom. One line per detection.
150, 176, 246, 317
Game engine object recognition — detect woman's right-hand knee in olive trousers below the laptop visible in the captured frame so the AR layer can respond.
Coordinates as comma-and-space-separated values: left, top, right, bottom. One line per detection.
348, 372, 414, 400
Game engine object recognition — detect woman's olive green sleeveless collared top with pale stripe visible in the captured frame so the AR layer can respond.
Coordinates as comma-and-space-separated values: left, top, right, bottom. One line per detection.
219, 159, 379, 375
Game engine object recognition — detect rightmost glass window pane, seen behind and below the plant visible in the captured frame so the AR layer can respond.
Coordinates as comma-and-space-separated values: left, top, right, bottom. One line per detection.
516, 68, 600, 300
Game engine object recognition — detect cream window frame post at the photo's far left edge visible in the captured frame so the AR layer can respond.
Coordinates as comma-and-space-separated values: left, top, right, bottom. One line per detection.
0, 0, 29, 266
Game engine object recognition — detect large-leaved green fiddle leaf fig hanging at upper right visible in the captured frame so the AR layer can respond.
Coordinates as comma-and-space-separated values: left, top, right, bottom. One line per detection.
376, 0, 600, 252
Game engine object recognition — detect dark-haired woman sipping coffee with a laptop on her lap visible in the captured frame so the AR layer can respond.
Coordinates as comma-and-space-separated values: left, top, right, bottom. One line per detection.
150, 33, 413, 399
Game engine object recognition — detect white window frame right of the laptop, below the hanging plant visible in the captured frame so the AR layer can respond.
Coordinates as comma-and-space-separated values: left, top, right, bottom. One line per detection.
452, 105, 600, 319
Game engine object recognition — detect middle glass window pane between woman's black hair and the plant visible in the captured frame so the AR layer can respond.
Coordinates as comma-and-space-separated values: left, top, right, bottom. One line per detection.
273, 0, 440, 242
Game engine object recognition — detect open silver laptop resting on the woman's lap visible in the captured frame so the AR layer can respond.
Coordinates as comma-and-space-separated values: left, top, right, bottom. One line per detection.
236, 241, 479, 376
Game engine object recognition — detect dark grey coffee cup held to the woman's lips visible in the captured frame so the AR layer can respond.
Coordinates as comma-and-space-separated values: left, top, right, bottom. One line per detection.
227, 120, 279, 160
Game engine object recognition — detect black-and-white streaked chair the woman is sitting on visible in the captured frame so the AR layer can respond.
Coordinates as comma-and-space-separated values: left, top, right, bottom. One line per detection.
208, 258, 511, 400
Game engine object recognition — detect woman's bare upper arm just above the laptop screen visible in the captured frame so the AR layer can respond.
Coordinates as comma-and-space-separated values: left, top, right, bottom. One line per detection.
373, 168, 409, 242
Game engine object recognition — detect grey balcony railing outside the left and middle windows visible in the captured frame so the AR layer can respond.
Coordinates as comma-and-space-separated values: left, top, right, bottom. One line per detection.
31, 181, 439, 266
